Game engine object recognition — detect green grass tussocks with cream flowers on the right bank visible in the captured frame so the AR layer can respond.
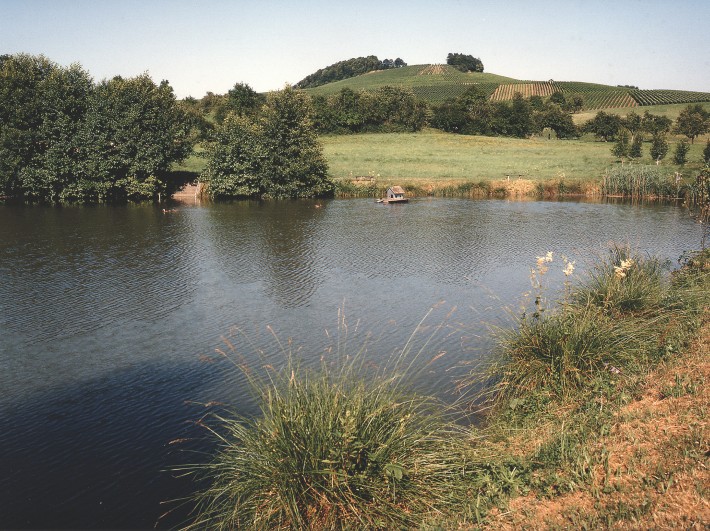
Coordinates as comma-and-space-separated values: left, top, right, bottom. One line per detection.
466, 246, 671, 408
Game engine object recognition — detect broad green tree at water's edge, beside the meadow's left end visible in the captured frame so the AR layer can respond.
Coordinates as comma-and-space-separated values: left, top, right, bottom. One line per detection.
202, 87, 334, 198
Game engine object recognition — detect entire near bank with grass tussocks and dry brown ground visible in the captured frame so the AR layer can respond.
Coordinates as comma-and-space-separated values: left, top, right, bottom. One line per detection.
179, 248, 710, 529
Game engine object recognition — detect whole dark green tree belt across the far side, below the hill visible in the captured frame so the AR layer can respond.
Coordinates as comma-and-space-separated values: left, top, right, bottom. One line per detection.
0, 54, 710, 202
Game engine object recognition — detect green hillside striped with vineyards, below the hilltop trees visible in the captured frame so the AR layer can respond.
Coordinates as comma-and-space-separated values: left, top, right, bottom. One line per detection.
306, 65, 710, 111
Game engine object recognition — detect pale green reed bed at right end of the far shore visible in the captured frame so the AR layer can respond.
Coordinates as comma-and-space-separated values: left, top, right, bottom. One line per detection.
602, 164, 678, 198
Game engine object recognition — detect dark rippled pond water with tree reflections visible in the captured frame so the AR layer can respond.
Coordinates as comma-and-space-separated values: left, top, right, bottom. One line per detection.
0, 199, 701, 528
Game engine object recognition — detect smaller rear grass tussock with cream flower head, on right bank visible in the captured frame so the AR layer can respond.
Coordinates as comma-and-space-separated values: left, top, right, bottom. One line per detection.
571, 245, 668, 315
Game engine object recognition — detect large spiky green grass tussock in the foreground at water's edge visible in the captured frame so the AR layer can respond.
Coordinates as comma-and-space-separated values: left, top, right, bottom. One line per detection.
179, 322, 467, 529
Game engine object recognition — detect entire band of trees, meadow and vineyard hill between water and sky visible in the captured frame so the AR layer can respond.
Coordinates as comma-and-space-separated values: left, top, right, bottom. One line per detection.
0, 53, 710, 203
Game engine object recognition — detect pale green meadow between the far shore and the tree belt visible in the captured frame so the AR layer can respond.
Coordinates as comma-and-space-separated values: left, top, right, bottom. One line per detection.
321, 130, 705, 186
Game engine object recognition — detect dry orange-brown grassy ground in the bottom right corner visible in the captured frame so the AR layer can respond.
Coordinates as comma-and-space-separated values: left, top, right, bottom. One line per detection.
487, 320, 710, 530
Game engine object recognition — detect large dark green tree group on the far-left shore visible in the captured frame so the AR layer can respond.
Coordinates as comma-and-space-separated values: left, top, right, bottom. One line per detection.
0, 54, 194, 202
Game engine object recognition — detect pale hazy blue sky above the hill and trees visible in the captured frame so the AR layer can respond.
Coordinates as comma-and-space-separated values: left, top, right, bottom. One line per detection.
0, 0, 710, 98
